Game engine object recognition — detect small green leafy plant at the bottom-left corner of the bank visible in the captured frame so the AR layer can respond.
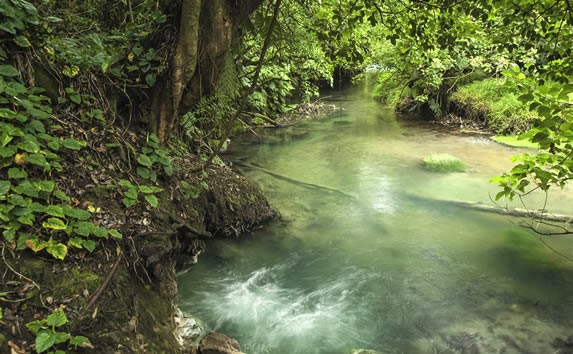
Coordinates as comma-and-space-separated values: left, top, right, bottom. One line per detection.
26, 310, 91, 354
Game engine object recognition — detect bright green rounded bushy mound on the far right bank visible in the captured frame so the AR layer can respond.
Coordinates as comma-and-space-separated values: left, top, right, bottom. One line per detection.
450, 78, 538, 135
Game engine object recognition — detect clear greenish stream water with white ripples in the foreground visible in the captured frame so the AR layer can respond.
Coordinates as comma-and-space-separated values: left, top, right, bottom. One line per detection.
179, 92, 573, 354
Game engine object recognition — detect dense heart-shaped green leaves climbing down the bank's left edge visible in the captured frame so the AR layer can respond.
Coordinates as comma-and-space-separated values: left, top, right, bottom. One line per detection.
0, 63, 121, 260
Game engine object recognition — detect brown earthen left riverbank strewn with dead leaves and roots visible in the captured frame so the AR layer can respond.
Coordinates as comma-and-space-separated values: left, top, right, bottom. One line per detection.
0, 114, 276, 353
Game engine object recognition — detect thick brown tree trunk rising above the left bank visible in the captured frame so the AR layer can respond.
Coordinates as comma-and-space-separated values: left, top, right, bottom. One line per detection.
150, 0, 263, 141
